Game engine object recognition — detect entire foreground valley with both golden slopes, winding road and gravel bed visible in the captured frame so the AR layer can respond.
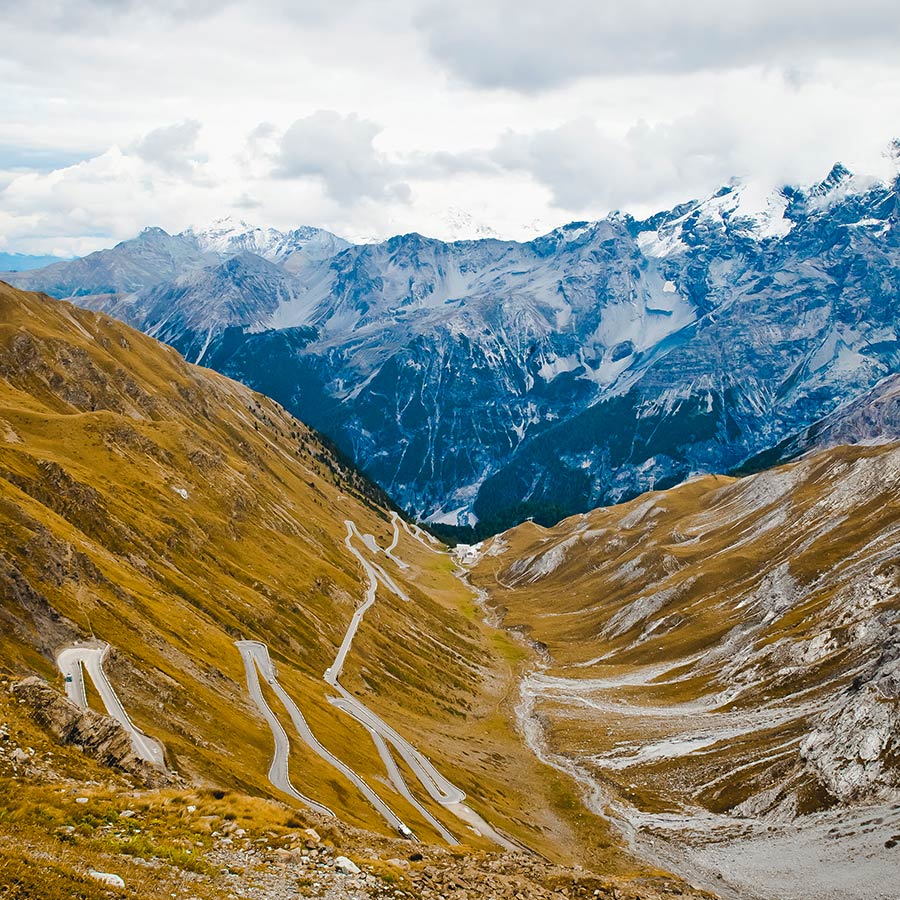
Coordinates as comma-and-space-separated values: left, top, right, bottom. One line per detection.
0, 282, 900, 900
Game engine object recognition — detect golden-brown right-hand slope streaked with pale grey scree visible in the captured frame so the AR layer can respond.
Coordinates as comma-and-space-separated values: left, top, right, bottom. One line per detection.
471, 445, 900, 817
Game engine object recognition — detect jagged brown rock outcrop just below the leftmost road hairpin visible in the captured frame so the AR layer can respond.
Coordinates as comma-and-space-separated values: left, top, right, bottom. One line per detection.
13, 676, 172, 787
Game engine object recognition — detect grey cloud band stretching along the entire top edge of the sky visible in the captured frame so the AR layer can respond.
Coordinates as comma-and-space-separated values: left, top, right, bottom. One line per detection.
8, 0, 900, 91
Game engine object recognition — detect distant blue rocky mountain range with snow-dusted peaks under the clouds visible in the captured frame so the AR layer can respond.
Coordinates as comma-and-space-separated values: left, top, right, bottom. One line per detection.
7, 145, 900, 536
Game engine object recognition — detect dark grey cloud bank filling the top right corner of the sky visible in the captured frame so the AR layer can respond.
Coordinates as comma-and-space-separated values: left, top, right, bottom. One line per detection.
415, 0, 900, 91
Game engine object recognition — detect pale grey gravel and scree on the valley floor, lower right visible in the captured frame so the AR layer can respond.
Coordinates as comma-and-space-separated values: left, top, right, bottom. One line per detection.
506, 652, 900, 900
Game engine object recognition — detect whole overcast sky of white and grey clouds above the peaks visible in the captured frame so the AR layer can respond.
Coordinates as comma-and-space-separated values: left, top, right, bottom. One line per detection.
0, 0, 900, 255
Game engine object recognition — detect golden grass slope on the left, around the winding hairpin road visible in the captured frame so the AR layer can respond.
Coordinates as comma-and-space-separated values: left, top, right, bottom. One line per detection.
0, 284, 612, 865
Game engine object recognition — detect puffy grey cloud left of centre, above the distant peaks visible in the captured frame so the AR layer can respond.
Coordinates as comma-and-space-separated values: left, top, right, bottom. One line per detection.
274, 110, 410, 206
